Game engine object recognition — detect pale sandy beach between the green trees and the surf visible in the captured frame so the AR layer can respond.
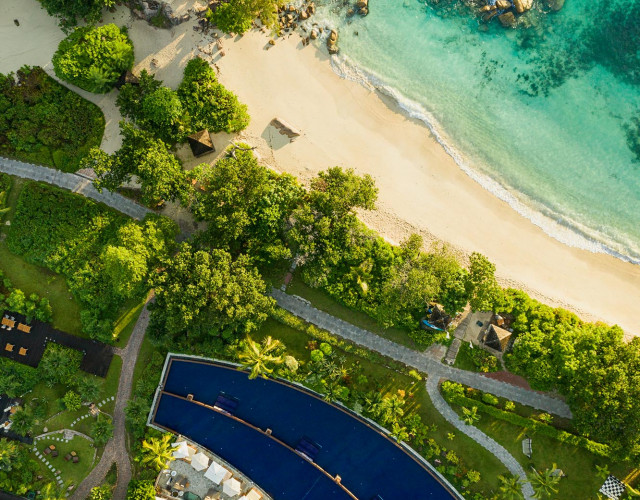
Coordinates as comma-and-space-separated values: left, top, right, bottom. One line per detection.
0, 0, 640, 335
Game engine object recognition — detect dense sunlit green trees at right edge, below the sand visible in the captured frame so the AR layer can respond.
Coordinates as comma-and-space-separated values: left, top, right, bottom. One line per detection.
496, 289, 640, 458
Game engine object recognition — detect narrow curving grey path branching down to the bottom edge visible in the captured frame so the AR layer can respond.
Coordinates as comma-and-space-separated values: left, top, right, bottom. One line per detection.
427, 376, 534, 500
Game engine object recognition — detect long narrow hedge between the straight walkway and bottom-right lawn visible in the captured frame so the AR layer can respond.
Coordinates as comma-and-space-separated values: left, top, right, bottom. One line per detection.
444, 394, 611, 457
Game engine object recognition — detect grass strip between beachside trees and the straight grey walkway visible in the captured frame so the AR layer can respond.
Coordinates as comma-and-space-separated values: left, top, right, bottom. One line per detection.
287, 274, 420, 350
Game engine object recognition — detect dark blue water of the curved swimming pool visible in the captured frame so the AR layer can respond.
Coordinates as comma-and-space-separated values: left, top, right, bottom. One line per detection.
155, 359, 453, 500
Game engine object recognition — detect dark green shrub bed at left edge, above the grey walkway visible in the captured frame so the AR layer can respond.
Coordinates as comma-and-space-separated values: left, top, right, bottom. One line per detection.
0, 66, 104, 172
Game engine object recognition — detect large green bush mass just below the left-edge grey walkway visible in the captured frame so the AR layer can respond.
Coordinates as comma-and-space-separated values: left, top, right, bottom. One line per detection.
7, 182, 177, 342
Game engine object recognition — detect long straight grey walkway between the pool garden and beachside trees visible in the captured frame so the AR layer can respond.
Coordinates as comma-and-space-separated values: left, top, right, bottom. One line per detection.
271, 290, 571, 418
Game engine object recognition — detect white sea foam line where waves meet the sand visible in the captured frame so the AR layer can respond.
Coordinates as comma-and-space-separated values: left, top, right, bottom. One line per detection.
331, 54, 640, 264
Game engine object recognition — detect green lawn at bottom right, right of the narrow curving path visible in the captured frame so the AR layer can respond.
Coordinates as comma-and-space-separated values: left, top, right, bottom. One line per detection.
453, 405, 631, 500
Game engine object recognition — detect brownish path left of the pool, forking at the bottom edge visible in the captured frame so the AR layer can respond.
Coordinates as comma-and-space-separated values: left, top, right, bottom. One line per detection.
70, 294, 152, 500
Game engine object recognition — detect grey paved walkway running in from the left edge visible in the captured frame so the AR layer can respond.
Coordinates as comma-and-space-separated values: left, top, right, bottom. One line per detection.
0, 157, 151, 220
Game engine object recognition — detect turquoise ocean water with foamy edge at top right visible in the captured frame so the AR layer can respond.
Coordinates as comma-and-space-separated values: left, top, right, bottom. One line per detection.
312, 0, 640, 262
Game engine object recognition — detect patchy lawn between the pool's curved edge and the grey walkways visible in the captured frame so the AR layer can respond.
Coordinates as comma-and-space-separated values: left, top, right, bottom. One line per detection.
252, 319, 507, 491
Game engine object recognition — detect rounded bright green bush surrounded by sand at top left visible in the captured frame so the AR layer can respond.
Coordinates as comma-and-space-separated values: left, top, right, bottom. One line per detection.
52, 24, 133, 94
